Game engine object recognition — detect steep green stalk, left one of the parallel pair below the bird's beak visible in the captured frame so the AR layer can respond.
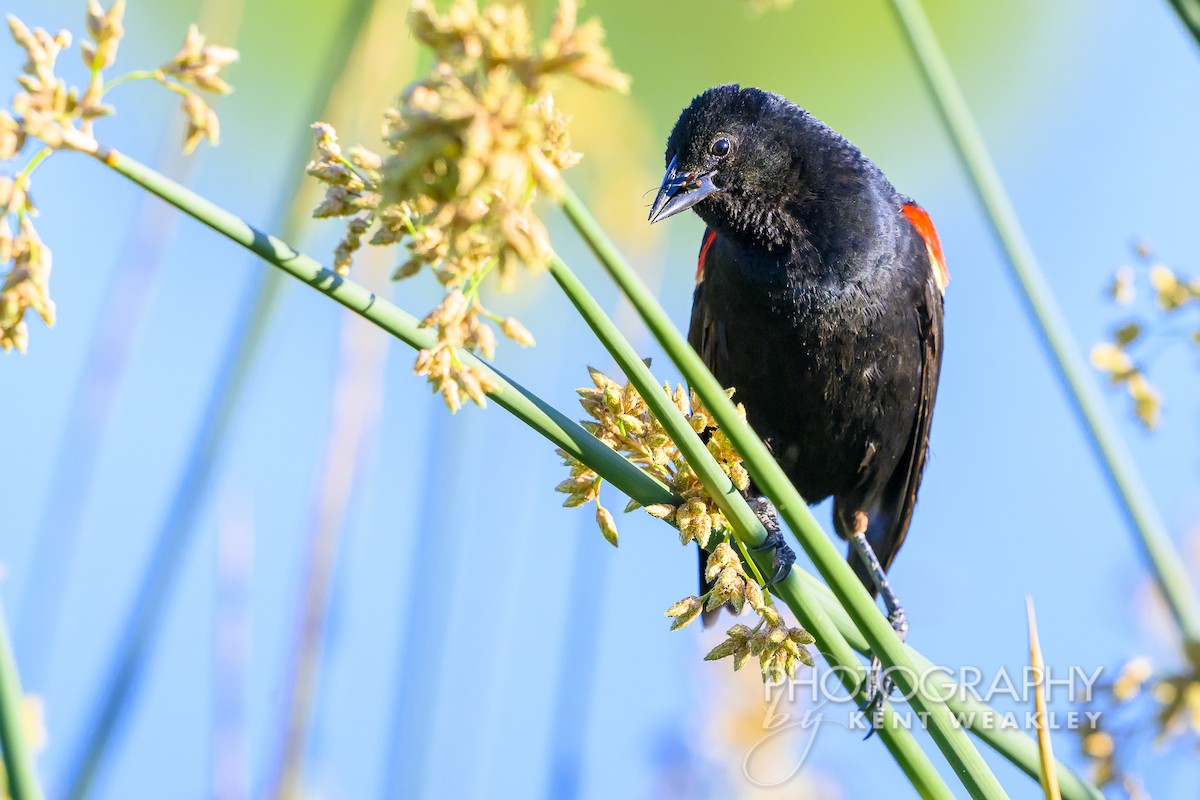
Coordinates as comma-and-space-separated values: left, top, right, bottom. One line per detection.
550, 255, 954, 798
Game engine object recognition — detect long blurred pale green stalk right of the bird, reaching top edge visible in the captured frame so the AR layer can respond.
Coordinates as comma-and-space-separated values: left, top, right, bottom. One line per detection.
890, 0, 1200, 657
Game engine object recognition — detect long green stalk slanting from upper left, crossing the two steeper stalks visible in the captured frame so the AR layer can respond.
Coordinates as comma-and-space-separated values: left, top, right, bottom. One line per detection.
88, 150, 1099, 800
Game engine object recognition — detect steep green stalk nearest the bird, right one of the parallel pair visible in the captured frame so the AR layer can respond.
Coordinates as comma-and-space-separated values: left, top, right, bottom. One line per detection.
562, 188, 1007, 798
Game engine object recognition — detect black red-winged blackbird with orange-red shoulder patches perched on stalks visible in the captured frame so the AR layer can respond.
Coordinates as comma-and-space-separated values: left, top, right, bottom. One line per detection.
650, 85, 949, 695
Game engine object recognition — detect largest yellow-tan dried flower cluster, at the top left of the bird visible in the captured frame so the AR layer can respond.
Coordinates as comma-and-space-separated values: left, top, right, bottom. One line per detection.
308, 0, 629, 410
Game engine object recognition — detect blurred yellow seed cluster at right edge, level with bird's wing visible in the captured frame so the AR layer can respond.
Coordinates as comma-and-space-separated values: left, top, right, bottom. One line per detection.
1092, 246, 1200, 428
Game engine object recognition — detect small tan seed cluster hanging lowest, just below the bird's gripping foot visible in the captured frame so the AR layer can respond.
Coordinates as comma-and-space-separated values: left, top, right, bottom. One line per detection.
666, 541, 814, 684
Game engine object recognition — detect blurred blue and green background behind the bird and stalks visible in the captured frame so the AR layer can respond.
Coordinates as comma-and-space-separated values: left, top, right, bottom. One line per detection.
0, 0, 1200, 798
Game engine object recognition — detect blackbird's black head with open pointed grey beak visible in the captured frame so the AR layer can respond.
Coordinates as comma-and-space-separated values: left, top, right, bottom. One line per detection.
650, 84, 823, 243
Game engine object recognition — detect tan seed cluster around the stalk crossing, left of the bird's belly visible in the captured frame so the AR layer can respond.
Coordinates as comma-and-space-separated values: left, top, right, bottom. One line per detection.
556, 367, 750, 549
